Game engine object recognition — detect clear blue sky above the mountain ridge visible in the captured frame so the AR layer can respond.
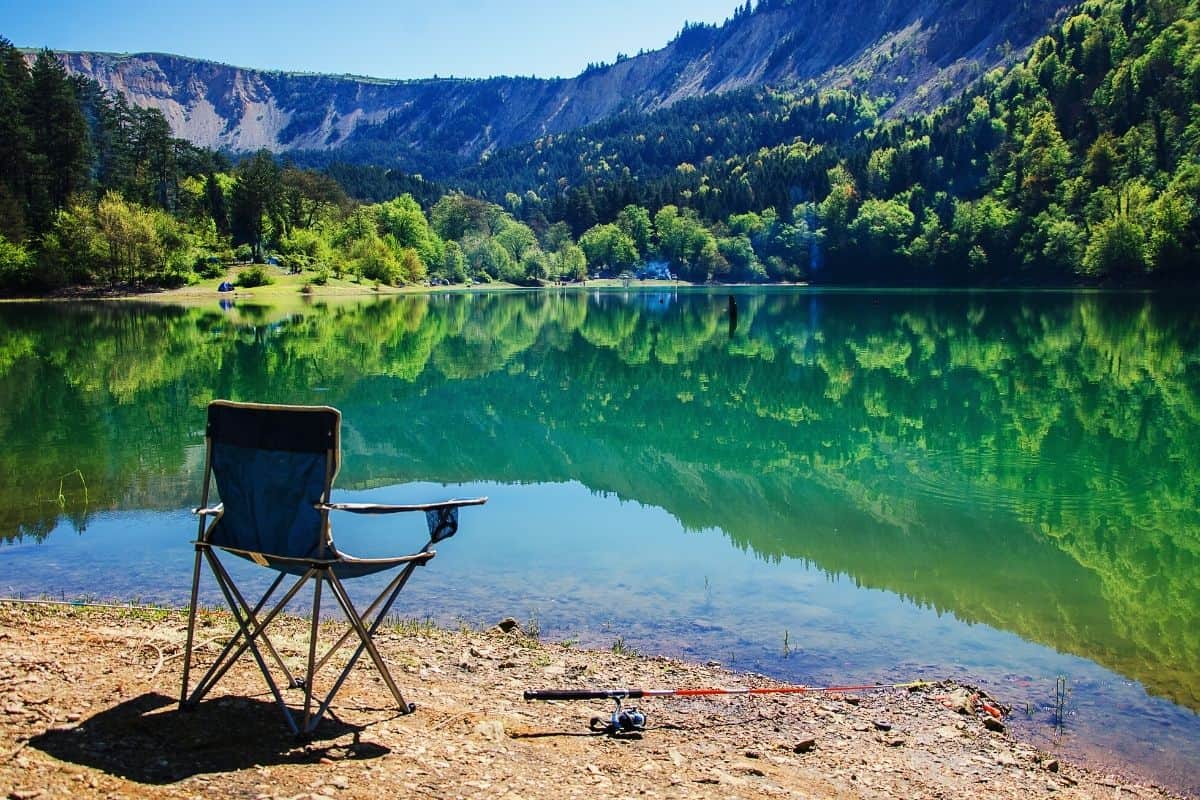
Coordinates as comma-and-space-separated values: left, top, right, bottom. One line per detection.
0, 0, 738, 78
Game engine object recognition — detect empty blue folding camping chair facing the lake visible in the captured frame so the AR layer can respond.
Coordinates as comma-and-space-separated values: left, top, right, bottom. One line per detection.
179, 401, 487, 736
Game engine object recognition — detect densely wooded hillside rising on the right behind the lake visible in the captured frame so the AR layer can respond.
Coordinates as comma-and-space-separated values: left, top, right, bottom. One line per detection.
453, 0, 1200, 284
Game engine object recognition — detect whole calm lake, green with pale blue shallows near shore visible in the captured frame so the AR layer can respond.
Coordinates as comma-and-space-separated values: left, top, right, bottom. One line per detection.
0, 289, 1200, 793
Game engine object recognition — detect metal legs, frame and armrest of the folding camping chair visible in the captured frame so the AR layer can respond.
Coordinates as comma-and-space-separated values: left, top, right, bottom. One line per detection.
179, 401, 487, 738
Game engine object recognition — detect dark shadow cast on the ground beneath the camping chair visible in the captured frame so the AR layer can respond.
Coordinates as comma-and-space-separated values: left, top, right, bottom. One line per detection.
29, 692, 390, 784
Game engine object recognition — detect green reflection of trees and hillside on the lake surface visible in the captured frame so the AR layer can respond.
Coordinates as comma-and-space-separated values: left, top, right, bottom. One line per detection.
0, 291, 1200, 782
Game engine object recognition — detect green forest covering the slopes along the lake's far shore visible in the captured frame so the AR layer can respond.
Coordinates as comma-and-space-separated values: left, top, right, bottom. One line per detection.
0, 0, 1200, 294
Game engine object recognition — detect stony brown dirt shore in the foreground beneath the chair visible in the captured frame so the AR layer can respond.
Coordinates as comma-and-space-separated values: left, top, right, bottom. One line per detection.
0, 603, 1172, 800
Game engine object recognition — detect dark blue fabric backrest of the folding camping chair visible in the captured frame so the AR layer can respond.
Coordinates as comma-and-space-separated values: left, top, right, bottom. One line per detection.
204, 401, 342, 559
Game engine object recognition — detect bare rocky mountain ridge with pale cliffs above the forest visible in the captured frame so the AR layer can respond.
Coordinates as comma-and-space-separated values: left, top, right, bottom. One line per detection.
49, 0, 1070, 175
